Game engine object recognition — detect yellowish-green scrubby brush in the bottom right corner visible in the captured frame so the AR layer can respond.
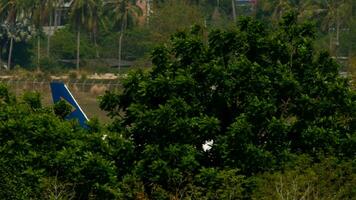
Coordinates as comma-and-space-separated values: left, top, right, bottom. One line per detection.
252, 158, 356, 199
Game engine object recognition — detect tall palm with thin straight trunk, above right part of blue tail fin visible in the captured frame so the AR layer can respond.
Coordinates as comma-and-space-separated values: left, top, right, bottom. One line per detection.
70, 0, 97, 71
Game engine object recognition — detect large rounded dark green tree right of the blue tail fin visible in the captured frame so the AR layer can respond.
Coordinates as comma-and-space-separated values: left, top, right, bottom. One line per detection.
101, 14, 356, 178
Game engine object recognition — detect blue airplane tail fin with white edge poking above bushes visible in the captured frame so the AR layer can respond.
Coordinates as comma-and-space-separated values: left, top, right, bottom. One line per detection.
51, 82, 88, 127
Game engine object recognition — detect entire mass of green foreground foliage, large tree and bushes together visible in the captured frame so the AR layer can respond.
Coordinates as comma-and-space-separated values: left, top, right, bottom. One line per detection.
0, 14, 356, 200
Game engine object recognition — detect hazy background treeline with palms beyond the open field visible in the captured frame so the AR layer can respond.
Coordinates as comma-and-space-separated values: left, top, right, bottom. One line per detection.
0, 0, 356, 71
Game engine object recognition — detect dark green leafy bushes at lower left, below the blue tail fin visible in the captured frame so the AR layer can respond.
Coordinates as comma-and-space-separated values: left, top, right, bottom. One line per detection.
0, 86, 133, 199
